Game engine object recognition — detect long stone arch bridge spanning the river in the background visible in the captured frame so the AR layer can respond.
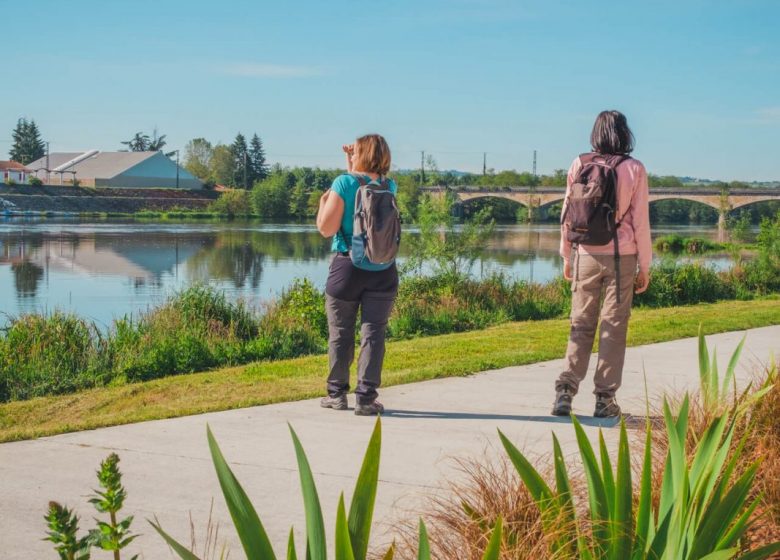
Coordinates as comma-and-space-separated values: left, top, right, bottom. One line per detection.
422, 186, 780, 225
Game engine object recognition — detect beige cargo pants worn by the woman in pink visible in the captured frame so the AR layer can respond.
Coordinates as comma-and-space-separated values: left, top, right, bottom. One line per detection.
555, 254, 637, 396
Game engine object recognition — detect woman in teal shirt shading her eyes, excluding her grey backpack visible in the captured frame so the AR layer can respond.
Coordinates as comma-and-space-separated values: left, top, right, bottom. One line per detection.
317, 134, 398, 416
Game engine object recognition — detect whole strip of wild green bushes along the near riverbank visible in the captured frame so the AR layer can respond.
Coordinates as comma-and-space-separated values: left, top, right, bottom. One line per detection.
0, 217, 780, 402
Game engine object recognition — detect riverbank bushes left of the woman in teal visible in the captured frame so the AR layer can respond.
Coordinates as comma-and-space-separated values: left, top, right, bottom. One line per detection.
0, 281, 327, 402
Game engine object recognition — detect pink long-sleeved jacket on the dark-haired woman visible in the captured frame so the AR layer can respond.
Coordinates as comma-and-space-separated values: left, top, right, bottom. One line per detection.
560, 156, 653, 272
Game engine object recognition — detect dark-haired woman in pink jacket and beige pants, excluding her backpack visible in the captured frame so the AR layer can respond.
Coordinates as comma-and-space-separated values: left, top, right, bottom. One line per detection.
552, 111, 652, 418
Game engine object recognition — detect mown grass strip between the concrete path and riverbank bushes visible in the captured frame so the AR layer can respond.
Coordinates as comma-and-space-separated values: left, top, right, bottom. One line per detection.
0, 297, 780, 441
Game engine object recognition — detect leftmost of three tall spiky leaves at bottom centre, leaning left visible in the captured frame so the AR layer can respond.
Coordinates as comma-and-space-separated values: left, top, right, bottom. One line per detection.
206, 426, 276, 560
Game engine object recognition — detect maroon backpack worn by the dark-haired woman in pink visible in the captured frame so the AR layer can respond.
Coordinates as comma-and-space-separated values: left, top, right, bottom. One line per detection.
561, 152, 630, 302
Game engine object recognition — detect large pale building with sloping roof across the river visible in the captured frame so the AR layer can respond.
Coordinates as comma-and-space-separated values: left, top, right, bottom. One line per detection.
27, 150, 203, 189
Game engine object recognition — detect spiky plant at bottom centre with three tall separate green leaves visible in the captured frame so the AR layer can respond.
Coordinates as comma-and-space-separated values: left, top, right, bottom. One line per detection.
149, 419, 501, 560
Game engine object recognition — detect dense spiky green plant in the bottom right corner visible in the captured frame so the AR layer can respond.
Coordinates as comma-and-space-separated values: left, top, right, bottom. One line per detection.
499, 396, 780, 560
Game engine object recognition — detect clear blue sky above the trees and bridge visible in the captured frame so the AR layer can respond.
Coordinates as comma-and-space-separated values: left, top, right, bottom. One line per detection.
0, 0, 780, 180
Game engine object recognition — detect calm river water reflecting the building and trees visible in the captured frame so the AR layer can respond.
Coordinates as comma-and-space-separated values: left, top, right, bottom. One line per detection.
0, 219, 730, 326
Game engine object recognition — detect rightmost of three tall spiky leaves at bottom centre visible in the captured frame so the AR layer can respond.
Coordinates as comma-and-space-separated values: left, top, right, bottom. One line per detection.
349, 417, 382, 560
